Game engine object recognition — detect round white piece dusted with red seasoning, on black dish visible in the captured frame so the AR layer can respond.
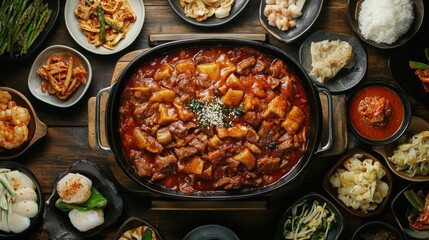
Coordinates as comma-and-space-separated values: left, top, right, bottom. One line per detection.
57, 173, 92, 204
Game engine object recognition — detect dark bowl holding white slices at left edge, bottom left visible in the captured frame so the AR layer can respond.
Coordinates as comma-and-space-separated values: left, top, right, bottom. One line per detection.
0, 161, 44, 239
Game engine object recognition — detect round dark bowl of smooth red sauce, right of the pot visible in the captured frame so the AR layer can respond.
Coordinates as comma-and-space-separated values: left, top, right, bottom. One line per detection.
347, 81, 411, 145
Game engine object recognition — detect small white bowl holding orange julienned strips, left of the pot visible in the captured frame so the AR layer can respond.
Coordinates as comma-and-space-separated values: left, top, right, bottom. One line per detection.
28, 45, 92, 108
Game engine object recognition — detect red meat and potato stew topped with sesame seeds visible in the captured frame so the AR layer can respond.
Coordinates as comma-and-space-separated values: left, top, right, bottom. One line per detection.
119, 46, 310, 194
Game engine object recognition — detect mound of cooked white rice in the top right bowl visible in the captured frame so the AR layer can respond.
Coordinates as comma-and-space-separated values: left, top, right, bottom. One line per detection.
358, 0, 414, 44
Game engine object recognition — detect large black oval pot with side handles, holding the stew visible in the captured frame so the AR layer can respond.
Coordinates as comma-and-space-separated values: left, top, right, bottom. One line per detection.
97, 38, 329, 199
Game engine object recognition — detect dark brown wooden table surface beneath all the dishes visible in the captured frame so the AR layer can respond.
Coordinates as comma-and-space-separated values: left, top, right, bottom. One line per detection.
0, 0, 429, 240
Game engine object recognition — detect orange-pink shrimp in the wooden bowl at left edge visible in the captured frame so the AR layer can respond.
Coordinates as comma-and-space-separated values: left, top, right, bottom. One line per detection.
0, 90, 31, 152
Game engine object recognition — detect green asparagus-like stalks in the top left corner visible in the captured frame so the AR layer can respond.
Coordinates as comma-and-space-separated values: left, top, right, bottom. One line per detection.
0, 0, 52, 57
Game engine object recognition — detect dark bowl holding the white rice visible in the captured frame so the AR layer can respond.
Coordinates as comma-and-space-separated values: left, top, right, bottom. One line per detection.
347, 0, 424, 49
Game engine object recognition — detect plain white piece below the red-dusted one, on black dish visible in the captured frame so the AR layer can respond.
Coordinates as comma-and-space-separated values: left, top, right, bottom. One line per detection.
69, 209, 104, 232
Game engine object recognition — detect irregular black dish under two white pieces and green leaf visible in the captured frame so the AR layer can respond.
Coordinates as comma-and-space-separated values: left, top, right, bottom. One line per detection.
43, 160, 123, 239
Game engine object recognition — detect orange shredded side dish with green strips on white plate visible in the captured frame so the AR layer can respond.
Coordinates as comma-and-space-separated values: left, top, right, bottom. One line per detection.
75, 0, 137, 49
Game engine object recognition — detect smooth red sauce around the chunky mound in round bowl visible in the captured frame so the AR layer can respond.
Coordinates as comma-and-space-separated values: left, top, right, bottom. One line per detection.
349, 85, 404, 140
